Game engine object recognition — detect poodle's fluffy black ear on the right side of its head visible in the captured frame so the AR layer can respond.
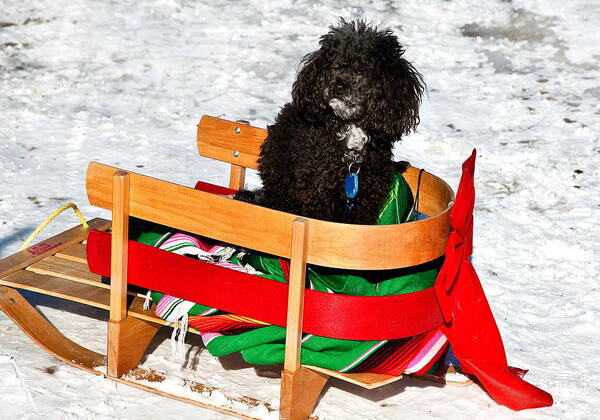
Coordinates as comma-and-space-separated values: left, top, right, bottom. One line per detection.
368, 30, 425, 142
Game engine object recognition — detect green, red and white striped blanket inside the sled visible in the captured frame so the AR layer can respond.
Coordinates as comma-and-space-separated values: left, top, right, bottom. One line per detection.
138, 174, 447, 375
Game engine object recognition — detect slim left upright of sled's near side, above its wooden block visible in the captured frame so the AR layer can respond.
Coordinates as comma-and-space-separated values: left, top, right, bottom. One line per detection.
110, 171, 129, 322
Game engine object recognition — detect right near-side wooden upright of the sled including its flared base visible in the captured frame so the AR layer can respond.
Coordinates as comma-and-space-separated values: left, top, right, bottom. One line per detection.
279, 217, 329, 420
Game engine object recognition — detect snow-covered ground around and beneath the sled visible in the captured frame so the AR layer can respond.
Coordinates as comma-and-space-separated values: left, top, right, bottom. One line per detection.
0, 0, 600, 419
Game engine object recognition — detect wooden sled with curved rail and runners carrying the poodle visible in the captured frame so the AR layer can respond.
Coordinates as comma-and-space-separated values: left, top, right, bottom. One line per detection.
0, 116, 471, 419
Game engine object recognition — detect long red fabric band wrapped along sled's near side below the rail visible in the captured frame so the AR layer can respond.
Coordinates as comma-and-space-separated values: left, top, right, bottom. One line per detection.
87, 230, 443, 340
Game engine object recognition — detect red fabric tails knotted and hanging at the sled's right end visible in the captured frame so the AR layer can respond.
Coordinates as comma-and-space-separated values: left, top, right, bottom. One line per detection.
435, 150, 553, 410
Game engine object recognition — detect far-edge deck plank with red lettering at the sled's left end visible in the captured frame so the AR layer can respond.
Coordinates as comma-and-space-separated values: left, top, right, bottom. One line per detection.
0, 218, 110, 278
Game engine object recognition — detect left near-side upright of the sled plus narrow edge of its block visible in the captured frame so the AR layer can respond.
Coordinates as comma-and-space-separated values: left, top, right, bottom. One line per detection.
107, 171, 129, 377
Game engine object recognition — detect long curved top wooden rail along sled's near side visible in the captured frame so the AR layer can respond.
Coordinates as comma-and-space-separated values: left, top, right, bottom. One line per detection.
87, 162, 450, 270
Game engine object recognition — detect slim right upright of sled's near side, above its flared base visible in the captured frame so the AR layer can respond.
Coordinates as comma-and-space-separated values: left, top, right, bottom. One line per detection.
284, 217, 308, 373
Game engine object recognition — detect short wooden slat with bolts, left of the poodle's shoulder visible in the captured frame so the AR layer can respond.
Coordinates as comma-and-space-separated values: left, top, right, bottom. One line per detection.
196, 115, 267, 169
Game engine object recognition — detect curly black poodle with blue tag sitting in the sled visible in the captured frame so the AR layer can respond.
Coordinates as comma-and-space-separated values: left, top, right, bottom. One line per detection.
236, 19, 424, 224
